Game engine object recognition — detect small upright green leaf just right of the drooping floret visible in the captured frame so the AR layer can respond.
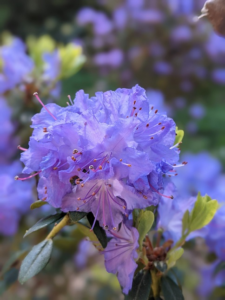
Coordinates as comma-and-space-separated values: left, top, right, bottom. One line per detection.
137, 211, 154, 249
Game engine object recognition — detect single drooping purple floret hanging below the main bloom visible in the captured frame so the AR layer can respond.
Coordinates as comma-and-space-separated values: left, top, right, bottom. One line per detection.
104, 223, 139, 294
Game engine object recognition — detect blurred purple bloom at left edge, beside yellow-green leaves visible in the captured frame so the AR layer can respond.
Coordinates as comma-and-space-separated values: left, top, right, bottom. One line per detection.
0, 38, 34, 94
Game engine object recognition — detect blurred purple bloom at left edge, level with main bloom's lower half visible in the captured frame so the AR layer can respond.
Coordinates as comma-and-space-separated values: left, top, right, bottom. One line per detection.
0, 162, 34, 235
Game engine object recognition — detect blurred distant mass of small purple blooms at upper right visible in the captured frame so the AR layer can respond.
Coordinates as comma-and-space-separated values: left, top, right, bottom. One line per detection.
76, 0, 225, 101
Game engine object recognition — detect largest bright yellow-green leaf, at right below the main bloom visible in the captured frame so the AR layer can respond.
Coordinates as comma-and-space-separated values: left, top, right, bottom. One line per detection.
189, 193, 219, 232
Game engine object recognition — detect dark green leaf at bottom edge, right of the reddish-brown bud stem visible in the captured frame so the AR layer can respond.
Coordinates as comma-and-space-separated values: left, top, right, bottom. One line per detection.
161, 277, 184, 300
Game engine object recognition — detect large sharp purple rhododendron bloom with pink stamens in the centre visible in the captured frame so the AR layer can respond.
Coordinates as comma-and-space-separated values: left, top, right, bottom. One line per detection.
18, 85, 179, 229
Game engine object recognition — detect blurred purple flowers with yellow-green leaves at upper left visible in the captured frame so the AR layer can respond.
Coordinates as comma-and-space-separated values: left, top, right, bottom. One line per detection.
0, 35, 85, 99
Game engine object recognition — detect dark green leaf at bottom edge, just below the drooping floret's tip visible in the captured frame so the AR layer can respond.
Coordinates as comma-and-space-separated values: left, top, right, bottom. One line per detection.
124, 270, 152, 300
